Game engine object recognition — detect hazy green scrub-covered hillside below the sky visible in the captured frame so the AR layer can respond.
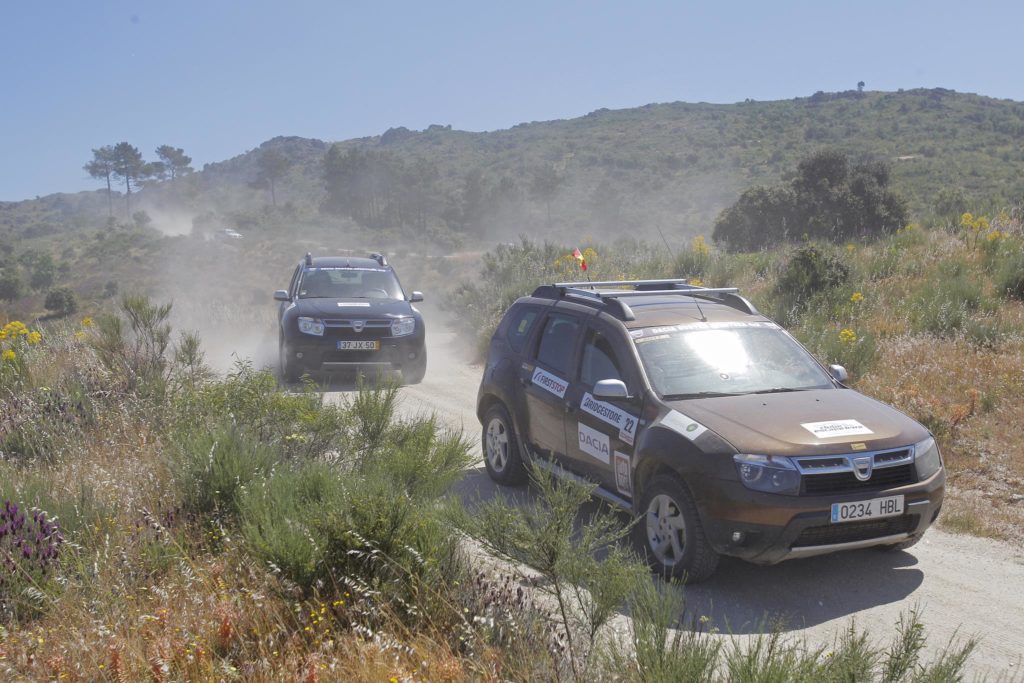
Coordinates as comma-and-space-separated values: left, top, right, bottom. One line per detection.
0, 89, 1024, 252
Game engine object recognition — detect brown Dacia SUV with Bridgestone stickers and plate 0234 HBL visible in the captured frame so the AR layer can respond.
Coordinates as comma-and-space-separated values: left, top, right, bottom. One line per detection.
477, 280, 945, 581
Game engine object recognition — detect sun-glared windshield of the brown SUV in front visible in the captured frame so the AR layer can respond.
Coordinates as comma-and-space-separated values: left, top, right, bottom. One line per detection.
632, 323, 831, 399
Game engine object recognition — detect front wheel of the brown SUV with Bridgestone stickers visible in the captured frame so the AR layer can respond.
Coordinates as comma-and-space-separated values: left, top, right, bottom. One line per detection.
634, 474, 719, 584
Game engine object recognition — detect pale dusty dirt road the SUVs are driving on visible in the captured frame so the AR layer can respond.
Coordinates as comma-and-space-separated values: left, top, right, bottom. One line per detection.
330, 328, 1024, 678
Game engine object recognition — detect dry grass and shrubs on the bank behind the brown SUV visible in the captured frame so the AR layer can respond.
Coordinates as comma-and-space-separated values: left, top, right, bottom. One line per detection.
450, 208, 1024, 544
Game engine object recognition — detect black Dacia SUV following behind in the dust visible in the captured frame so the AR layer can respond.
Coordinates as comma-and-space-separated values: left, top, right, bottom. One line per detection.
273, 254, 427, 384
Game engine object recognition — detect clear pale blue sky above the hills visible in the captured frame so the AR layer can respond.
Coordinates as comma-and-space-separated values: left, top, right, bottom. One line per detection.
0, 0, 1024, 201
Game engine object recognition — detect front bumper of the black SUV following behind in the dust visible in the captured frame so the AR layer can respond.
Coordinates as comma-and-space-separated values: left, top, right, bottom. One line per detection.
283, 326, 425, 375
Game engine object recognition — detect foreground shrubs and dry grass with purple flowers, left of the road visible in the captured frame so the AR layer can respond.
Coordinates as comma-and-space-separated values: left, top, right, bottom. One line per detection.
0, 296, 987, 681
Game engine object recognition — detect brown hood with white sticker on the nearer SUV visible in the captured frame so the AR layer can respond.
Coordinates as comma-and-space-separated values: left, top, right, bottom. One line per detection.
669, 389, 928, 456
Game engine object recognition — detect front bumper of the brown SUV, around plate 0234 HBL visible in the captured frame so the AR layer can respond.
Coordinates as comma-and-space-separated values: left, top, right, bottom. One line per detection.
694, 469, 945, 564
